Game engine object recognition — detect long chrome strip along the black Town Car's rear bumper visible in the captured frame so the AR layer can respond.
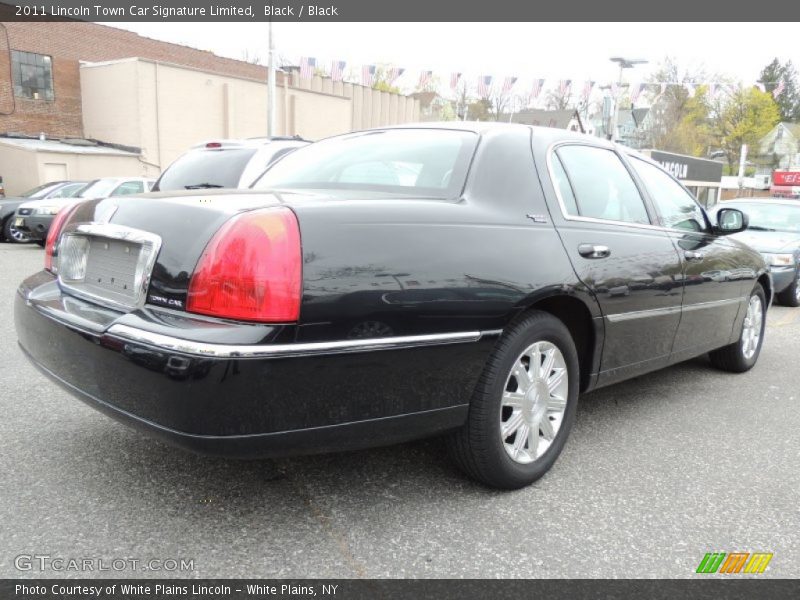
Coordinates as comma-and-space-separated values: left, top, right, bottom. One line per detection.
105, 323, 502, 359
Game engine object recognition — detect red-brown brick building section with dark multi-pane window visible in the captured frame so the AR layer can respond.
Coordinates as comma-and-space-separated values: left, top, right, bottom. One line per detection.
0, 21, 282, 137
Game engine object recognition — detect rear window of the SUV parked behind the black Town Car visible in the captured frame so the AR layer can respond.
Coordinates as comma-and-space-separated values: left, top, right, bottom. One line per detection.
157, 148, 256, 191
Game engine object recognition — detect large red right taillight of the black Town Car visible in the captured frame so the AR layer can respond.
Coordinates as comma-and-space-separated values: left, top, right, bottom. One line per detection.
186, 207, 302, 323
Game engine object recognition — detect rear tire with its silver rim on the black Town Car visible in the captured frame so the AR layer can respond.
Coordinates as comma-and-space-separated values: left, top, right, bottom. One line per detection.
448, 311, 580, 489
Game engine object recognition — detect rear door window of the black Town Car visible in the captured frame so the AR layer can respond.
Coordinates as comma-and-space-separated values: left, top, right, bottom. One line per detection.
554, 145, 650, 224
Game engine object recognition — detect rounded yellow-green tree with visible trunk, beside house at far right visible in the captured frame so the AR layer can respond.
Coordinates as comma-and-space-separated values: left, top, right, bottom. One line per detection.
708, 87, 781, 173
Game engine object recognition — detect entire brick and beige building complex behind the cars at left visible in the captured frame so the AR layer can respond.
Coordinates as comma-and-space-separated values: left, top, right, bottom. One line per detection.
0, 18, 419, 194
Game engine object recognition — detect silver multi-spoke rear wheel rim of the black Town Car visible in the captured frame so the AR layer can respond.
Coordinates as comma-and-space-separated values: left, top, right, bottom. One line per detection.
500, 342, 569, 464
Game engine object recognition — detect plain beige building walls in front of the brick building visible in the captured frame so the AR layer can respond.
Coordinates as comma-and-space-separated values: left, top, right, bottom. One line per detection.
81, 58, 419, 169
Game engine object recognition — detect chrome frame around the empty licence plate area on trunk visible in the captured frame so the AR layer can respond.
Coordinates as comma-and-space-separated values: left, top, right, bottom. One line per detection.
58, 223, 161, 311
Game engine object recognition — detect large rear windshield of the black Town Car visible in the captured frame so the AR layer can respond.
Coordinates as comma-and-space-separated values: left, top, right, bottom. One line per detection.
253, 129, 478, 199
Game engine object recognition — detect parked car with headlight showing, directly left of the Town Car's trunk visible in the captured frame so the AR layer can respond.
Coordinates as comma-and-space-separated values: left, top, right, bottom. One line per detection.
14, 177, 153, 244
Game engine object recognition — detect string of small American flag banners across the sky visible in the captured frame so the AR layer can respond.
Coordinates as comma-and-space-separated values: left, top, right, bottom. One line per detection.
300, 56, 786, 104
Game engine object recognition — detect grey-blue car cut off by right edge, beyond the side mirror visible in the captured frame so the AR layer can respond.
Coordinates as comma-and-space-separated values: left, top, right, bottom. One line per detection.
717, 198, 800, 306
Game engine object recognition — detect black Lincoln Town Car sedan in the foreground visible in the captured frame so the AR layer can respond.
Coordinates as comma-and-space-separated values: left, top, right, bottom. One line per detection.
15, 123, 772, 488
